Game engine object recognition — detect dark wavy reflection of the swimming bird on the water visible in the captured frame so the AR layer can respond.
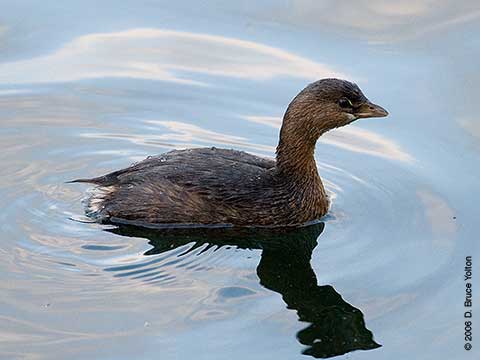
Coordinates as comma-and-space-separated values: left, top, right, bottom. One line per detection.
107, 223, 381, 358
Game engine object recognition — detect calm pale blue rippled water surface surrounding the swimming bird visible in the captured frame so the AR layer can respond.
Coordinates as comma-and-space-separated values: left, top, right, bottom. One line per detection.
0, 0, 480, 360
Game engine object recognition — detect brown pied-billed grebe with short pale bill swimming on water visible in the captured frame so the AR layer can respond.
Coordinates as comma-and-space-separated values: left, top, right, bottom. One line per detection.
73, 79, 388, 226
